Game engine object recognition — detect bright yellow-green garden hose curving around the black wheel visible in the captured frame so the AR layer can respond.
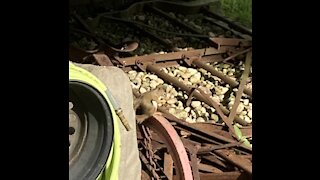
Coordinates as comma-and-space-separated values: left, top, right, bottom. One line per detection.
69, 62, 121, 180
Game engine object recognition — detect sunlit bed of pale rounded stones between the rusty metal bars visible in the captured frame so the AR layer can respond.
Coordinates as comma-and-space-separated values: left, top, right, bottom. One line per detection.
127, 58, 252, 127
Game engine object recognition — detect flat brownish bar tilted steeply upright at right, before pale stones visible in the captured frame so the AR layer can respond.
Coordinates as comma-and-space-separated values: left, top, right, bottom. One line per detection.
228, 51, 252, 125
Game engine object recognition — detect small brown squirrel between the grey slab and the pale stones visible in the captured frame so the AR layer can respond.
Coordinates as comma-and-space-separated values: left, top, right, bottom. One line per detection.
134, 86, 166, 124
